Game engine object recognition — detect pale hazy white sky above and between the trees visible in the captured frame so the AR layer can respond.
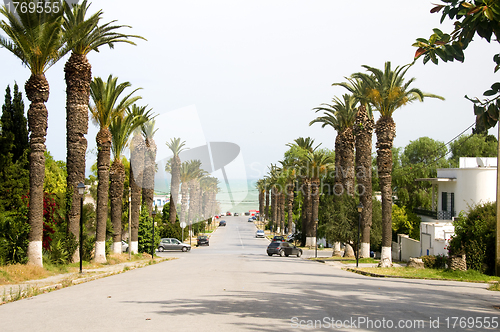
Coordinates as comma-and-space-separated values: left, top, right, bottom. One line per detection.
0, 0, 497, 184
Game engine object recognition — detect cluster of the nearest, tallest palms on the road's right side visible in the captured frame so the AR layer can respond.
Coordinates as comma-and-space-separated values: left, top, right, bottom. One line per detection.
310, 62, 443, 266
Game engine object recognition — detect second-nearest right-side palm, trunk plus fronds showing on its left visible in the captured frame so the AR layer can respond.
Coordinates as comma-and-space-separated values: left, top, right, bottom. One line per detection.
333, 78, 375, 257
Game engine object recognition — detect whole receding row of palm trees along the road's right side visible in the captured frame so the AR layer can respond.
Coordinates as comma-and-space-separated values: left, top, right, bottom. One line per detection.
257, 62, 443, 266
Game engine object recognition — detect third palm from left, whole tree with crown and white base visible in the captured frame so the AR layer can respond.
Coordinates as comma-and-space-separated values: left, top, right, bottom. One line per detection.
90, 75, 141, 263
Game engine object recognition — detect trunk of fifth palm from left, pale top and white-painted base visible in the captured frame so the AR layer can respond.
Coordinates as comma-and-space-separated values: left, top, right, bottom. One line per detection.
130, 134, 145, 253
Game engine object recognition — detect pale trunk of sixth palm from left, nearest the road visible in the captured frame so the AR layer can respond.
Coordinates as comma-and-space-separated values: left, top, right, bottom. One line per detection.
141, 119, 158, 216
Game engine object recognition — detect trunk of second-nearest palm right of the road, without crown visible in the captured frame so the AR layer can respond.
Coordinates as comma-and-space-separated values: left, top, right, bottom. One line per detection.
354, 106, 374, 257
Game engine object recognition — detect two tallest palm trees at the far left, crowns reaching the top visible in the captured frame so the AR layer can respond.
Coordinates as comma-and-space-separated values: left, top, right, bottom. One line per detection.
0, 0, 142, 266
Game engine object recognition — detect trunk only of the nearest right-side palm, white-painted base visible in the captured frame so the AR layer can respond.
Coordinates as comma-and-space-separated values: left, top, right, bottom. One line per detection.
375, 116, 396, 267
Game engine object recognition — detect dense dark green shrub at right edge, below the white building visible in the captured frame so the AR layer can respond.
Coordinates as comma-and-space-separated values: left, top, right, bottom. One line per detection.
448, 202, 496, 275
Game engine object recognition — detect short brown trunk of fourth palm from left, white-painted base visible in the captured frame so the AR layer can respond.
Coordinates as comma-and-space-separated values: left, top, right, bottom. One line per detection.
109, 159, 125, 254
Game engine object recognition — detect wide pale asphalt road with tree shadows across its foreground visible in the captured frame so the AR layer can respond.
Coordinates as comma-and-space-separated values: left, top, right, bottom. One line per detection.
0, 216, 500, 332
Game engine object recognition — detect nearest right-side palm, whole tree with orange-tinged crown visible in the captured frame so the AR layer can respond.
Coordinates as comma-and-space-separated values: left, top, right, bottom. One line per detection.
352, 61, 444, 267
